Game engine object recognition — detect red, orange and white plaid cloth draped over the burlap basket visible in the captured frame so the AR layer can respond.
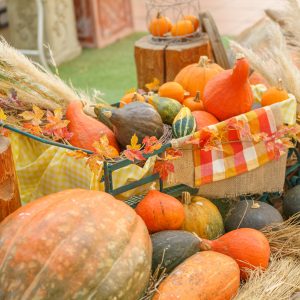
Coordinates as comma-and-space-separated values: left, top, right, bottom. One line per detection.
194, 99, 296, 186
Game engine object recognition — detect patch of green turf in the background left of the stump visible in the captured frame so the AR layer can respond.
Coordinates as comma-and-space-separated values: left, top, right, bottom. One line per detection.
58, 33, 145, 103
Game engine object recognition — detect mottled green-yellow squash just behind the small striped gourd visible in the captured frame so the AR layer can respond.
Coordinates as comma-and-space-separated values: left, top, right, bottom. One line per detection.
147, 95, 182, 125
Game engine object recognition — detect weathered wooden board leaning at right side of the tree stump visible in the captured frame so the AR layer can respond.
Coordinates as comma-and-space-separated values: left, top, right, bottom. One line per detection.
200, 12, 231, 69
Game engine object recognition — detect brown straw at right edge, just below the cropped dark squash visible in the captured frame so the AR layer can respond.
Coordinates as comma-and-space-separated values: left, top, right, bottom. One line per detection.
261, 212, 300, 258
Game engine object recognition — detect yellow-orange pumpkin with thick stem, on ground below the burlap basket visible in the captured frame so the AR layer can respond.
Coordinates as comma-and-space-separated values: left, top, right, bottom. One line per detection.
181, 192, 224, 240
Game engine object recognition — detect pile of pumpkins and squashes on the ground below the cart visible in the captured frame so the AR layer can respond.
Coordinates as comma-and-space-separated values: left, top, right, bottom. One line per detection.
0, 186, 299, 300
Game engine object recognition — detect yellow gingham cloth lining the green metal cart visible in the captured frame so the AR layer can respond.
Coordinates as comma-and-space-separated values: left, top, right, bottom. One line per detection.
10, 133, 156, 203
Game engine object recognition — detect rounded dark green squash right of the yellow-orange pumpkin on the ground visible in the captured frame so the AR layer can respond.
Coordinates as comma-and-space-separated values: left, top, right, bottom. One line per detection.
225, 200, 283, 232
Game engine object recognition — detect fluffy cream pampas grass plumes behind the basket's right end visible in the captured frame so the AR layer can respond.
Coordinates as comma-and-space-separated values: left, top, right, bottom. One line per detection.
231, 21, 300, 103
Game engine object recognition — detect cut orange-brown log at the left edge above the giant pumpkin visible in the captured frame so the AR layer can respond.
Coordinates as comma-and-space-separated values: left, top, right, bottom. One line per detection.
0, 136, 21, 222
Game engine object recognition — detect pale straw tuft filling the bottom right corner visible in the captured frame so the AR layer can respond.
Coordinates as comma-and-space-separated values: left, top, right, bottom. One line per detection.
234, 257, 300, 300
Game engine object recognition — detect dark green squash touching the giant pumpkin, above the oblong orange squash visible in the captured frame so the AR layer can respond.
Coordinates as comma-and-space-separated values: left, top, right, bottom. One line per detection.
151, 230, 199, 273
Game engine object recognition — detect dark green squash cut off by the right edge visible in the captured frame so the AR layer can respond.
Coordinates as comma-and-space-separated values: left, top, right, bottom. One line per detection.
283, 185, 300, 222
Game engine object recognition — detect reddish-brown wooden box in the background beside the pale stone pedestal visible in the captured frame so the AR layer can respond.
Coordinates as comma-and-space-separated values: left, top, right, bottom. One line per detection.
74, 0, 133, 48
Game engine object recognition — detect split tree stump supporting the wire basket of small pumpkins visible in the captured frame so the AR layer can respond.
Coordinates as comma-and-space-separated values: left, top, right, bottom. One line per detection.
135, 34, 212, 89
